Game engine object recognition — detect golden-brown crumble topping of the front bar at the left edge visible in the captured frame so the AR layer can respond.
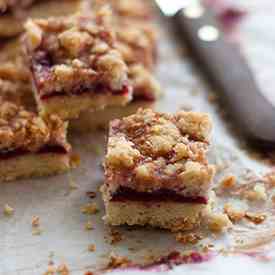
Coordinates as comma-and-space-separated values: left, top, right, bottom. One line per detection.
0, 97, 70, 152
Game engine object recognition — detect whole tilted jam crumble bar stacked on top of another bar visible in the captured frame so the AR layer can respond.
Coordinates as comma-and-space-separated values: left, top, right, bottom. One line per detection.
25, 9, 132, 120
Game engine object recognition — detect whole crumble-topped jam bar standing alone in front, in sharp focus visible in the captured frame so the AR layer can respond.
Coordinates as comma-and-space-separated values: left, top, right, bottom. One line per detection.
101, 109, 217, 231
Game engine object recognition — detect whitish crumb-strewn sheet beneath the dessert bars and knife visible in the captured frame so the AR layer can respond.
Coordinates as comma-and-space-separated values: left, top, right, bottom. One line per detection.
0, 0, 275, 275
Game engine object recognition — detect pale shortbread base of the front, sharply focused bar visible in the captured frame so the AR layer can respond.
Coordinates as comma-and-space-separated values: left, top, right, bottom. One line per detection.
101, 186, 207, 232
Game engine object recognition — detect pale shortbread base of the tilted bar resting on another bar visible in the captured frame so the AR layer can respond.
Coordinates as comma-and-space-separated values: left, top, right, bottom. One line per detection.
36, 93, 131, 120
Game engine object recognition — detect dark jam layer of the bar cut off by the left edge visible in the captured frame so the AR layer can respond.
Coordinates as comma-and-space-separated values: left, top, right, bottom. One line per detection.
0, 145, 68, 160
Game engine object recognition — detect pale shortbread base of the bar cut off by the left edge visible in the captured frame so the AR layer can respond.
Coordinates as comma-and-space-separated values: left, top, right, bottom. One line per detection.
0, 153, 71, 182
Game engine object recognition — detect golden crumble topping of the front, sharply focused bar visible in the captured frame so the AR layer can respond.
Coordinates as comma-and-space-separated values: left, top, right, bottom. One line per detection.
105, 109, 214, 196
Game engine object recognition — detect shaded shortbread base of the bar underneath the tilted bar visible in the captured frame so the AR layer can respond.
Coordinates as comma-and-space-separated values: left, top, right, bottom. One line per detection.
69, 100, 155, 132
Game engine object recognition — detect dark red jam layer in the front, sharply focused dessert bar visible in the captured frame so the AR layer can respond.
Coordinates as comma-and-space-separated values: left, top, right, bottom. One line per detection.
111, 187, 208, 204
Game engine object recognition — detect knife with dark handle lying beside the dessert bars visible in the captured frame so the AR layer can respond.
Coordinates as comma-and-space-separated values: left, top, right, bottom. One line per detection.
155, 0, 275, 149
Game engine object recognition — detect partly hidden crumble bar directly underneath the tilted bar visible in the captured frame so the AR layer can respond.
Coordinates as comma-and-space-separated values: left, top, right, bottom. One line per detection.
70, 65, 161, 132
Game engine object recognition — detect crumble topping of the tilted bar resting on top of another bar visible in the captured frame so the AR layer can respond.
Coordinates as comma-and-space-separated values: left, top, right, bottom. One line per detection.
25, 7, 128, 96
